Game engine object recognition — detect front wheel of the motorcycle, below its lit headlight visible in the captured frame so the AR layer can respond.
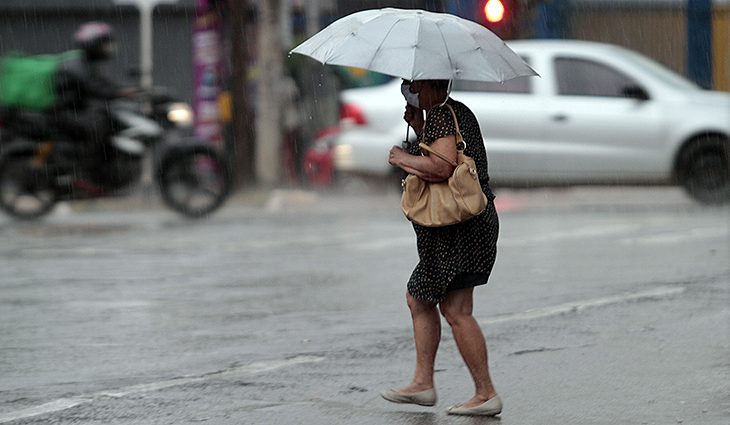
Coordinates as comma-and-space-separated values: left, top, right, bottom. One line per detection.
158, 146, 231, 218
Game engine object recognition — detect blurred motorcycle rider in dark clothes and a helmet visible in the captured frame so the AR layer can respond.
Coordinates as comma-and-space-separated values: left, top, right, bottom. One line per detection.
53, 22, 135, 176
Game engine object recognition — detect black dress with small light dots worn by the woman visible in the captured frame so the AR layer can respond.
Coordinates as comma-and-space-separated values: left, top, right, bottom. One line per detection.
408, 98, 499, 303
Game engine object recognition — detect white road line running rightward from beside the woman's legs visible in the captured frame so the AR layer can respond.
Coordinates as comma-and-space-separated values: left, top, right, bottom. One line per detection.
479, 286, 686, 325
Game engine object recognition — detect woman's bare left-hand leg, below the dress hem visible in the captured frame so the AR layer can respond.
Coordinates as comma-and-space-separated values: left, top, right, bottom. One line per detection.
399, 294, 441, 393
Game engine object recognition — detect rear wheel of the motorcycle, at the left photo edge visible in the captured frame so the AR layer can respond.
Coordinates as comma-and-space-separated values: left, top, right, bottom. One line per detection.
0, 154, 58, 220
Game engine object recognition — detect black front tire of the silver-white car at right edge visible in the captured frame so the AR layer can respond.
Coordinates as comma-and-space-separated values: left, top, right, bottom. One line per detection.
677, 136, 730, 205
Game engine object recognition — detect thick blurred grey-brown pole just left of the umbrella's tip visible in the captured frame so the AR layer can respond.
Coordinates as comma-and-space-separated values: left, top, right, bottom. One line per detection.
256, 0, 283, 186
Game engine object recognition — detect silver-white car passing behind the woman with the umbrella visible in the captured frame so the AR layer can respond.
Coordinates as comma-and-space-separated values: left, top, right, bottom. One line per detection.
333, 40, 730, 204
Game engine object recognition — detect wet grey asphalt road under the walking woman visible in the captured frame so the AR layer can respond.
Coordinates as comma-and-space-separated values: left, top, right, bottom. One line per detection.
0, 188, 730, 425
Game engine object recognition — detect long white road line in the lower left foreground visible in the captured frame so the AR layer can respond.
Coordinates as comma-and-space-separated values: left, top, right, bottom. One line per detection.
0, 356, 325, 424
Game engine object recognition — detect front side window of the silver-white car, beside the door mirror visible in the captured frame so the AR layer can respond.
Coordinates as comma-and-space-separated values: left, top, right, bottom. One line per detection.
555, 58, 638, 97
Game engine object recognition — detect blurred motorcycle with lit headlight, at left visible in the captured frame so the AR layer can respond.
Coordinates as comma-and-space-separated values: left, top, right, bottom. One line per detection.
0, 89, 232, 219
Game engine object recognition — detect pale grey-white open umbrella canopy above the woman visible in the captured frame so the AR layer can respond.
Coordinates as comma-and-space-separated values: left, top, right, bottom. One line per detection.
290, 8, 537, 81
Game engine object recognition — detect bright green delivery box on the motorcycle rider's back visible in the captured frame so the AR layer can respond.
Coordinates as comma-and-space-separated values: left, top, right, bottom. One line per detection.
0, 50, 80, 111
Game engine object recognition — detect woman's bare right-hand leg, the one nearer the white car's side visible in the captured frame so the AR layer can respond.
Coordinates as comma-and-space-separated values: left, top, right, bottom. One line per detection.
440, 288, 497, 408
